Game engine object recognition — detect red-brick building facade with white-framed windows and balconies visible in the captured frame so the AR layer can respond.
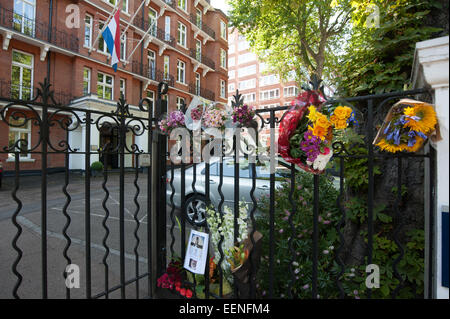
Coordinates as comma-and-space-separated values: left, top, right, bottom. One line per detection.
0, 0, 228, 171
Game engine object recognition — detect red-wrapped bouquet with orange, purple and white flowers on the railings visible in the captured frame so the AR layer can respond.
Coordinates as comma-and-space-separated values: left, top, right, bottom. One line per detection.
278, 90, 357, 174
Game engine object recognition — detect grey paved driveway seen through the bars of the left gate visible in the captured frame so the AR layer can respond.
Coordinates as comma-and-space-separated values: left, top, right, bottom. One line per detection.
0, 173, 186, 298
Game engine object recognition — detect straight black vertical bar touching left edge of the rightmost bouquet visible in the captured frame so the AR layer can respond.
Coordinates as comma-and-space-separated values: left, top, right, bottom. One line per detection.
366, 100, 374, 299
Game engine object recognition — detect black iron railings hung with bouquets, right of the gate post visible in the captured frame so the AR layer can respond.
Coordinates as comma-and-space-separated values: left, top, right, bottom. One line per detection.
158, 85, 434, 299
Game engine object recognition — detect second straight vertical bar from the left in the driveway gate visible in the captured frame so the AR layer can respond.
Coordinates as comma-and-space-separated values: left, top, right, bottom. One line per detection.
84, 112, 91, 299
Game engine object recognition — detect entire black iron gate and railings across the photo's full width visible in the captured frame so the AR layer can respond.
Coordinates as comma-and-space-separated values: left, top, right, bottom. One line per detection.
0, 82, 434, 299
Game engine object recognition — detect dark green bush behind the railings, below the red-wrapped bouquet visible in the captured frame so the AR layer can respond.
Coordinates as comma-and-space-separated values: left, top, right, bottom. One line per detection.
257, 172, 424, 299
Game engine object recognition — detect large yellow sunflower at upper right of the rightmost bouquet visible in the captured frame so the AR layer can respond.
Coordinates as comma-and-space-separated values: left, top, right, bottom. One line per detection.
403, 104, 437, 134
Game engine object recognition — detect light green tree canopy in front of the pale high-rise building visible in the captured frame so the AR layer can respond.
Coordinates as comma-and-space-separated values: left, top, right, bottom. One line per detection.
229, 0, 353, 82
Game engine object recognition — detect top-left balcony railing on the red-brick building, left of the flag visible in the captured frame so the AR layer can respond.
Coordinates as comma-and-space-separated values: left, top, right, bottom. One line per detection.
0, 5, 79, 53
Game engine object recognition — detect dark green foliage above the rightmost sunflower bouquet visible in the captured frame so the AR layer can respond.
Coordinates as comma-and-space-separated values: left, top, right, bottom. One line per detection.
335, 0, 440, 96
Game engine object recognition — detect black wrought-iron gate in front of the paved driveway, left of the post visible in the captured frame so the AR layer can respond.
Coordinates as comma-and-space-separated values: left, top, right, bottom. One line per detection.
0, 80, 154, 298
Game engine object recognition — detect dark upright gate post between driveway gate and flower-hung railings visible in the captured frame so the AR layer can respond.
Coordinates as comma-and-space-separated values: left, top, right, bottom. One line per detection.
153, 82, 168, 282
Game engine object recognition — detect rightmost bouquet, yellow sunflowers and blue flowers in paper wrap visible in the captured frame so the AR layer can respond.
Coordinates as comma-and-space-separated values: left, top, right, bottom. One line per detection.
374, 99, 438, 153
